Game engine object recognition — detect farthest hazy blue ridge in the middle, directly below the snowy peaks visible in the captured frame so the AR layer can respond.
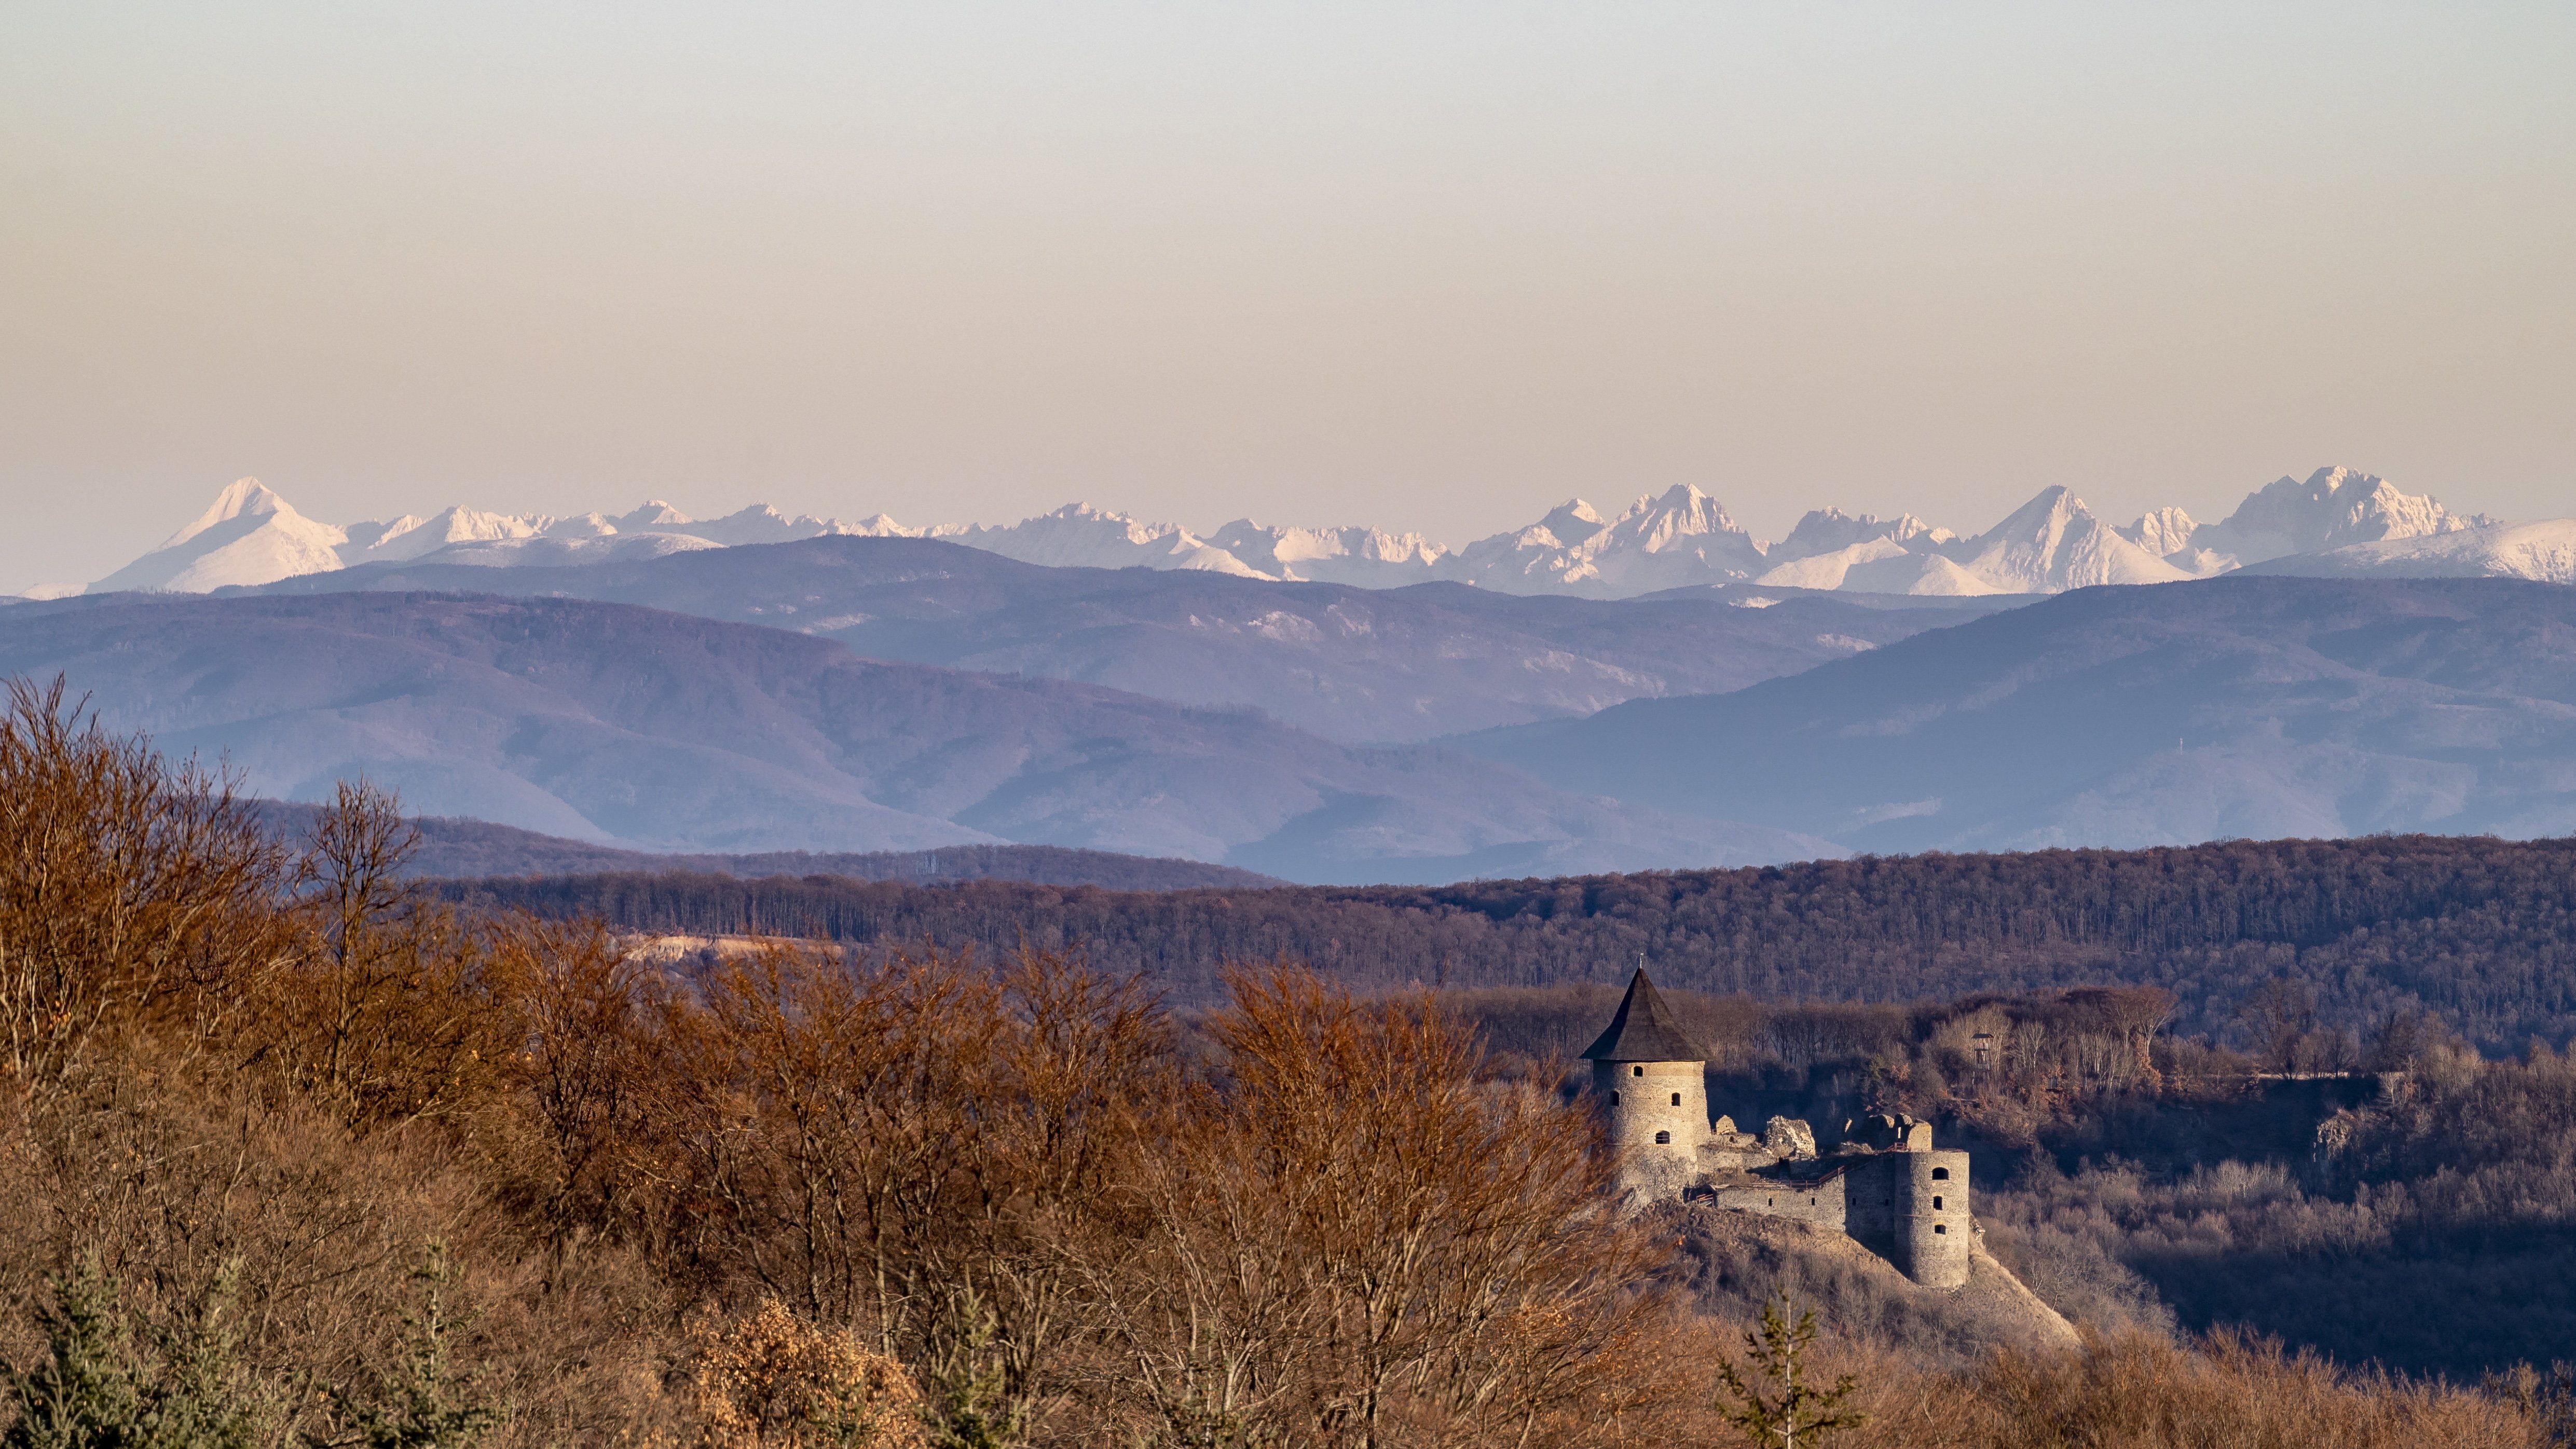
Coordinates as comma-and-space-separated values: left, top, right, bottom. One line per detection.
246, 536, 2020, 743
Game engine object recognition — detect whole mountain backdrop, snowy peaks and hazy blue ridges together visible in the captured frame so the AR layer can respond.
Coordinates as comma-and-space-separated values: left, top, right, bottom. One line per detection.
0, 469, 2576, 882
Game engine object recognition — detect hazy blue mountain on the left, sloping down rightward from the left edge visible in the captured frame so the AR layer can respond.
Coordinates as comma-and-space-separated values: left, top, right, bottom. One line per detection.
0, 593, 1834, 882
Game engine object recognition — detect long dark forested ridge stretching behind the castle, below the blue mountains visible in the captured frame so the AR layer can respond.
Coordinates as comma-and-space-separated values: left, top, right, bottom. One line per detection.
443, 836, 2576, 1049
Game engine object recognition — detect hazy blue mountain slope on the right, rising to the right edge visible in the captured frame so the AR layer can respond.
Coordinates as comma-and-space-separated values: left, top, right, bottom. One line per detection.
1453, 575, 2576, 851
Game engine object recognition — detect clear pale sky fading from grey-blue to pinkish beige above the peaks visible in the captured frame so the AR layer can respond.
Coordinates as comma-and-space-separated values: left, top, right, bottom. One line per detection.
0, 0, 2576, 588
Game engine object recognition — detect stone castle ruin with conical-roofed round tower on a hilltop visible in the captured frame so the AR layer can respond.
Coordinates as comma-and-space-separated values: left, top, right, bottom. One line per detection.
1584, 969, 1976, 1289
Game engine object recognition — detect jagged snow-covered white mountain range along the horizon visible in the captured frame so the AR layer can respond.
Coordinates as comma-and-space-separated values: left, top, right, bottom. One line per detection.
44, 467, 2545, 598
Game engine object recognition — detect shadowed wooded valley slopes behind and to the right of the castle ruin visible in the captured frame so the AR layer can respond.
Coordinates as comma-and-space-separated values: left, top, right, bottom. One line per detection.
1440, 985, 2576, 1379
